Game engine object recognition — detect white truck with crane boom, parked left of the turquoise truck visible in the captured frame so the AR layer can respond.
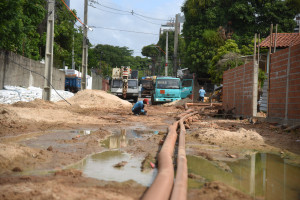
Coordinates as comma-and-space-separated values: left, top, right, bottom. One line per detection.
110, 66, 139, 102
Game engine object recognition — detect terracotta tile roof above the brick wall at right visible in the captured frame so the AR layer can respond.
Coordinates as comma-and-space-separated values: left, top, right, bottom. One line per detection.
260, 33, 300, 47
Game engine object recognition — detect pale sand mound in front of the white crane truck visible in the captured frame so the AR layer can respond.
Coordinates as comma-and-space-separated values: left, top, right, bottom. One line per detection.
67, 90, 132, 108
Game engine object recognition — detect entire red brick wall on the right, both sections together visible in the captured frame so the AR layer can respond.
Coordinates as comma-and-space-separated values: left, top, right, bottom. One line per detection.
223, 45, 300, 124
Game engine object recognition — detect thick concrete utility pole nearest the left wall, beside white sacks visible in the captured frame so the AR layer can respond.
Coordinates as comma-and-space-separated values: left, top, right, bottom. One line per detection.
42, 0, 55, 101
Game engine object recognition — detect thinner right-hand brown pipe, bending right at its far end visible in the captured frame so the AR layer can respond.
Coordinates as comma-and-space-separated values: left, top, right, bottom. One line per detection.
171, 111, 198, 200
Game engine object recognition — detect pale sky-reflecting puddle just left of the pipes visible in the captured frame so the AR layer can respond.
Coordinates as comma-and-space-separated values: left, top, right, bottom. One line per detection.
73, 151, 157, 186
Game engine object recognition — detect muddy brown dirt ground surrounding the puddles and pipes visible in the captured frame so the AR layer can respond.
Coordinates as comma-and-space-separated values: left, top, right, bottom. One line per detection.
0, 90, 300, 199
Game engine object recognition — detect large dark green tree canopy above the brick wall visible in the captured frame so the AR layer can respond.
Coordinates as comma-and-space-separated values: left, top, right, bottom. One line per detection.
182, 0, 299, 82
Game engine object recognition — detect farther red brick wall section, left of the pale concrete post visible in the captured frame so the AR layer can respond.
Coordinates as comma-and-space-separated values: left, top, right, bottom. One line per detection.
223, 62, 254, 116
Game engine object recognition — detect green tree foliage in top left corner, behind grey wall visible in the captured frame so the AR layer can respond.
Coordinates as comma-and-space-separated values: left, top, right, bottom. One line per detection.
0, 0, 46, 60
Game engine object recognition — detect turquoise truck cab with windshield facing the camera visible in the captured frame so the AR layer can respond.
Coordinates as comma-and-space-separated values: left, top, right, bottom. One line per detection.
151, 77, 181, 105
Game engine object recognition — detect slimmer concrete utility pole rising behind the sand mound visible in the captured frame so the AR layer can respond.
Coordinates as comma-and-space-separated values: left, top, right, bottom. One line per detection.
81, 0, 88, 90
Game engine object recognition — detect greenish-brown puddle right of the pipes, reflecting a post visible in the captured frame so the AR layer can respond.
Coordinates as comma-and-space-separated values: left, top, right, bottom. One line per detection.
187, 153, 300, 200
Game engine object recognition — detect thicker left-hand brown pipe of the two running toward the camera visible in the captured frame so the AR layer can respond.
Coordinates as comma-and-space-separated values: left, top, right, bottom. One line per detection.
142, 121, 178, 200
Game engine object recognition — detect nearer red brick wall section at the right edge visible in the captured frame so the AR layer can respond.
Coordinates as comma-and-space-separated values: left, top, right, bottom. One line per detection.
268, 45, 300, 120
